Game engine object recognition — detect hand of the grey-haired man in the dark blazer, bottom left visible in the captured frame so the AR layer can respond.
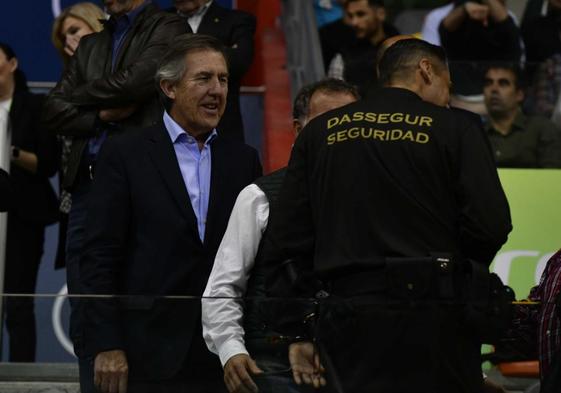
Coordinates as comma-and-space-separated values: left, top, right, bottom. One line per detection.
94, 350, 129, 393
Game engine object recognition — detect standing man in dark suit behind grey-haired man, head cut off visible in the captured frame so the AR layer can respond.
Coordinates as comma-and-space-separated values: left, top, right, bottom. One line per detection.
171, 0, 257, 142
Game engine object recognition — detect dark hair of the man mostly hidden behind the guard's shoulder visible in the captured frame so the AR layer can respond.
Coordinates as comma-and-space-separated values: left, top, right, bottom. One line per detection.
292, 78, 360, 121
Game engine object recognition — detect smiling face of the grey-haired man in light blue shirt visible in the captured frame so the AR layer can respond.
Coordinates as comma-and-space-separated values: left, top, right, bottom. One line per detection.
161, 50, 228, 137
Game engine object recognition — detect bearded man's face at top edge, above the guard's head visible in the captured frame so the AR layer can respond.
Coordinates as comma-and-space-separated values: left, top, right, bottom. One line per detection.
345, 0, 386, 39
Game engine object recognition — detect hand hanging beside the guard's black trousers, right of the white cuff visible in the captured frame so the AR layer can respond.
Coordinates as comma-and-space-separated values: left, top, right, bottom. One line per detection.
288, 342, 325, 389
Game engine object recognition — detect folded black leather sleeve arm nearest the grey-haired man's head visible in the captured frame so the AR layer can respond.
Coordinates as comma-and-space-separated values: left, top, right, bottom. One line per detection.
70, 14, 186, 108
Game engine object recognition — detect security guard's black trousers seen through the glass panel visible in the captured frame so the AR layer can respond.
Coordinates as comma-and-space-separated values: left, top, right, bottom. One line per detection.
318, 297, 483, 393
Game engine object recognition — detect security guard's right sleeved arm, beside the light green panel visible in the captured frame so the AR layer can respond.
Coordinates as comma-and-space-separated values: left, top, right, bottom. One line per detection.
456, 110, 512, 265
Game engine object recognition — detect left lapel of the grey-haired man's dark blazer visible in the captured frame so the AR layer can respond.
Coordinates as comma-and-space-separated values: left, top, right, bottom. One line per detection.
148, 123, 199, 231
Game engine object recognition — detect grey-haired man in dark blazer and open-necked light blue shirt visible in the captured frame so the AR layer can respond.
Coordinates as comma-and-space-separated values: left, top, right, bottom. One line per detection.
80, 34, 261, 393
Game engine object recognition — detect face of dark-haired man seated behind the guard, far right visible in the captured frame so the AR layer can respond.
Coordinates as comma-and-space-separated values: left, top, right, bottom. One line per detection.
483, 68, 524, 114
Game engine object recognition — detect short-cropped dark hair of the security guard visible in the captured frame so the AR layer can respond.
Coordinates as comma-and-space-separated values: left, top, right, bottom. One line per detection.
378, 38, 448, 86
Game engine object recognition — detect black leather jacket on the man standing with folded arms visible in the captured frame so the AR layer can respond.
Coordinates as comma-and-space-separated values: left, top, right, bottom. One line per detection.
44, 4, 187, 188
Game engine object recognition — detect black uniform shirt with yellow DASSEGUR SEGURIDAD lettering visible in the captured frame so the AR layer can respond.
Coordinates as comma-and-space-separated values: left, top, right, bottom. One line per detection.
271, 88, 511, 274
